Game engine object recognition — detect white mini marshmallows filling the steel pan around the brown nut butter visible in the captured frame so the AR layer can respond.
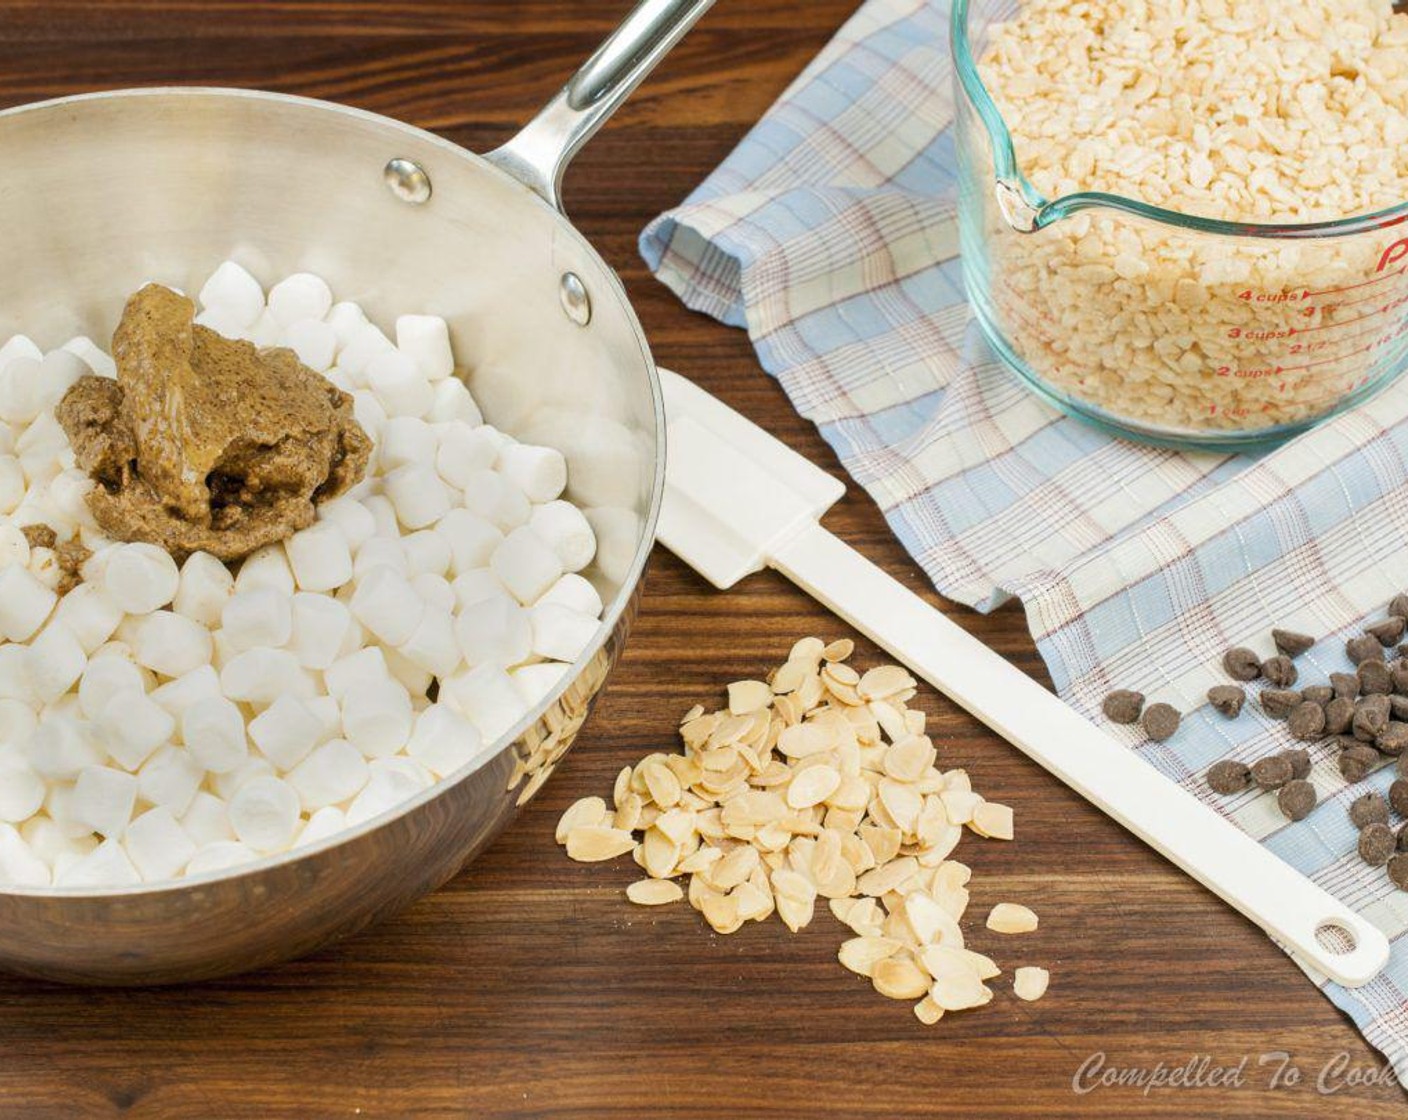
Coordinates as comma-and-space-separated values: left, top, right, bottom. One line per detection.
0, 262, 603, 888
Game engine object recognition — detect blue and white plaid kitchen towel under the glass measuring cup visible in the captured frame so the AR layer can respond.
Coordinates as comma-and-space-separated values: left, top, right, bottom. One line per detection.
641, 0, 1408, 1083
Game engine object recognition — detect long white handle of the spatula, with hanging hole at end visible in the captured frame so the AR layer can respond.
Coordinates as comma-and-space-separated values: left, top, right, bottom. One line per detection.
770, 524, 1388, 988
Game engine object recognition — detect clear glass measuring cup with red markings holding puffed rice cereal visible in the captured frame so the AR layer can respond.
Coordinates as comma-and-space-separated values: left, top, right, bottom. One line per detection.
950, 0, 1408, 451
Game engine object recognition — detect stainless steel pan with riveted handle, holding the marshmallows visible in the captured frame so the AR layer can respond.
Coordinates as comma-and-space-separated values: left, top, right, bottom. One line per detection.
0, 0, 712, 983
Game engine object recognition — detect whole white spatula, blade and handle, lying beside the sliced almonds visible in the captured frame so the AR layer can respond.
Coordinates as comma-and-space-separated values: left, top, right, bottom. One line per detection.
659, 369, 1388, 986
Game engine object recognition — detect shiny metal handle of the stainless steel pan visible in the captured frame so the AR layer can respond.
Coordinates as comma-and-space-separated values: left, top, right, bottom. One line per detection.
486, 0, 714, 210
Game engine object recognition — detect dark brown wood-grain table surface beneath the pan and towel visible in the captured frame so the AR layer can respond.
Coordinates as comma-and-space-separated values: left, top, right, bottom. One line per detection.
0, 0, 1404, 1120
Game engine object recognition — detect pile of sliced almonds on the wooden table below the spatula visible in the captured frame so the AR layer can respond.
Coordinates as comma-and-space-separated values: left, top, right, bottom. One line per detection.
558, 638, 1049, 1023
